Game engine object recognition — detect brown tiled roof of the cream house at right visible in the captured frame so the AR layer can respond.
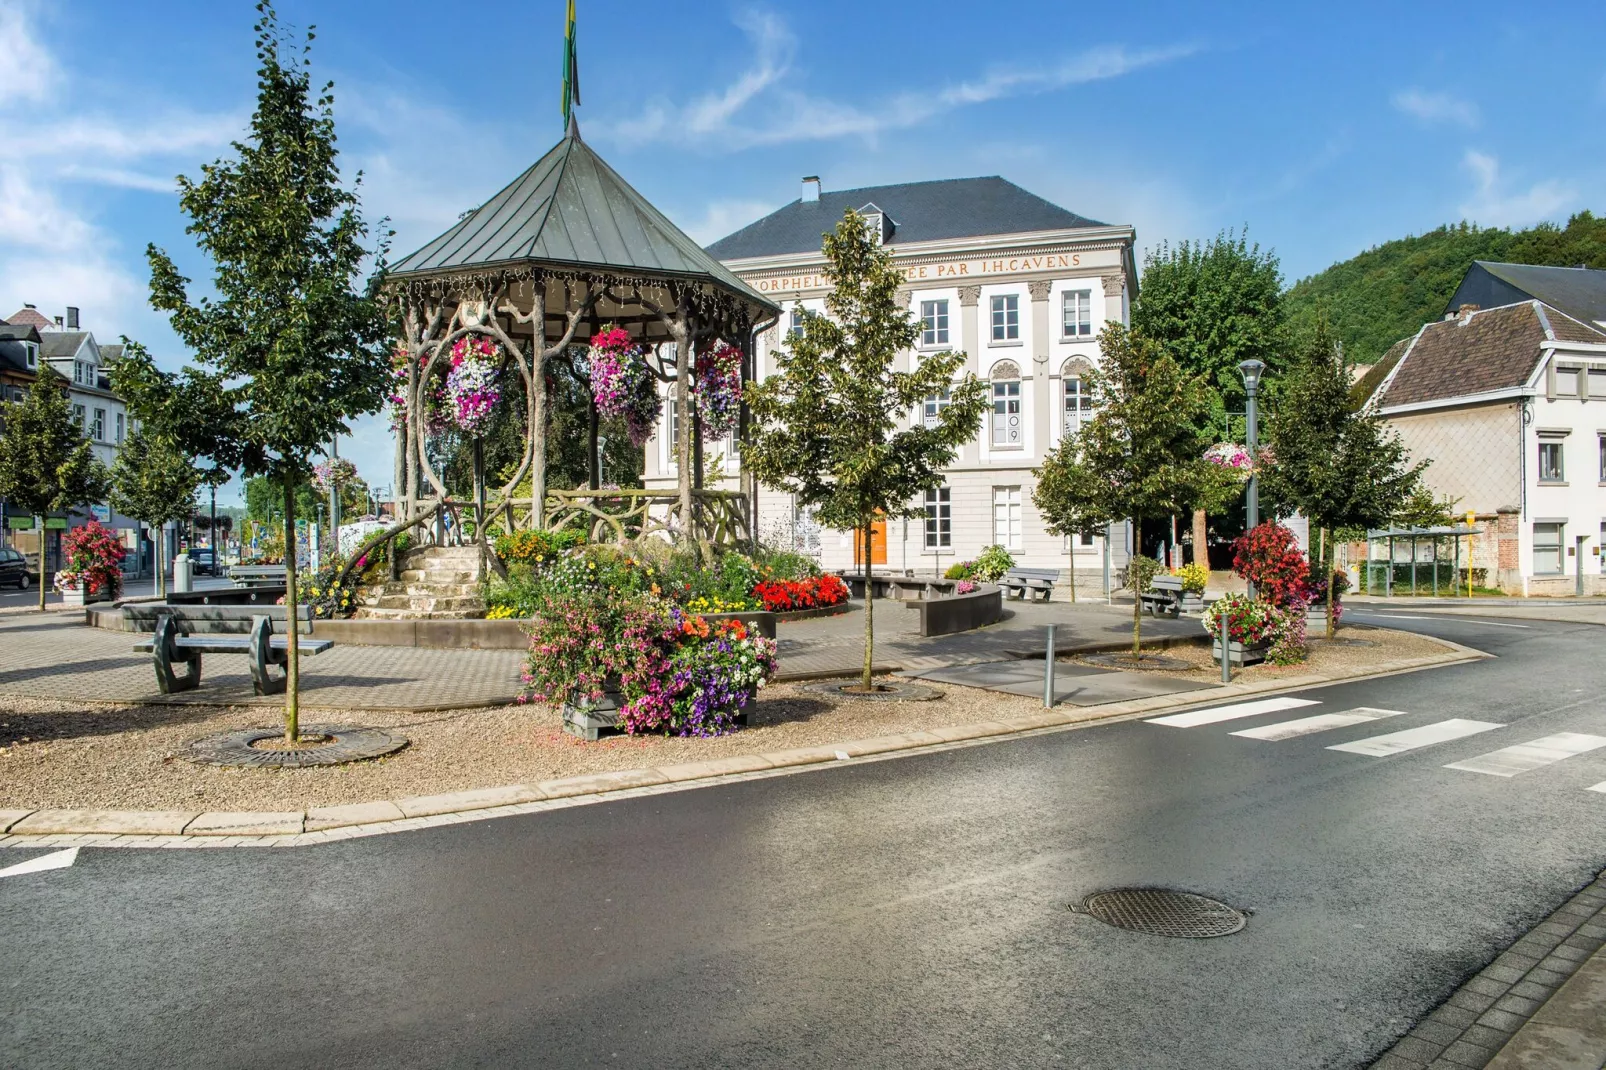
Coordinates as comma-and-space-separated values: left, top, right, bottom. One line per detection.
1368, 300, 1606, 408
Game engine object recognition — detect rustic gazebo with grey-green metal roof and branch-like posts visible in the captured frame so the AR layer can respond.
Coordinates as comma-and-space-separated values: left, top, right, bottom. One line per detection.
385, 119, 781, 562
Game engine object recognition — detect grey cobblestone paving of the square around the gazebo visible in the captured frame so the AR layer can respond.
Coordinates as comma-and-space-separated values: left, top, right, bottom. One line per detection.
0, 601, 1198, 710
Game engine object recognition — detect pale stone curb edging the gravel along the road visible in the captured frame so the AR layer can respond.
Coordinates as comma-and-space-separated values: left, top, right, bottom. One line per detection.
0, 639, 1492, 847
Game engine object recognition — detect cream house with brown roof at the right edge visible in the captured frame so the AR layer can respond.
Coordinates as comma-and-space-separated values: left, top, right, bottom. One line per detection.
1360, 282, 1606, 594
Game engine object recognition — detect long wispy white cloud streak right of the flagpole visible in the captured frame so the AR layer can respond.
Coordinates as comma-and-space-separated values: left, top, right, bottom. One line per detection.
586, 11, 1200, 148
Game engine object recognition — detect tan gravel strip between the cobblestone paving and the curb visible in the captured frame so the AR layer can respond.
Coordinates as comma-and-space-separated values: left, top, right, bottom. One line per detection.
0, 628, 1445, 810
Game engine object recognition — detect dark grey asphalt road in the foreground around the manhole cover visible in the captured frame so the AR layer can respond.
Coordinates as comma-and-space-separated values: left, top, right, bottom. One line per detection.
0, 611, 1606, 1070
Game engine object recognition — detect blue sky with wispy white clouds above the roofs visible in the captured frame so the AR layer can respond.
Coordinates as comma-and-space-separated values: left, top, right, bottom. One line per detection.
0, 0, 1606, 503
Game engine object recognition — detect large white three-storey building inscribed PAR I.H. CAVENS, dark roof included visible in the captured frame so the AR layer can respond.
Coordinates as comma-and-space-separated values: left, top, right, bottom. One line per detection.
646, 177, 1137, 586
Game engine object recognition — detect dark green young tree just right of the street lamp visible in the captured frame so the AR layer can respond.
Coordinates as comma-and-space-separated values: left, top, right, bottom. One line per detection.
1264, 320, 1431, 635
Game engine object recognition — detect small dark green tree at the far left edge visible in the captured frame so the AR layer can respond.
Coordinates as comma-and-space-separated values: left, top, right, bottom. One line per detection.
0, 366, 106, 612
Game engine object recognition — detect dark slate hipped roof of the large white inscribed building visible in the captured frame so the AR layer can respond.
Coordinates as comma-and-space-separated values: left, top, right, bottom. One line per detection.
708, 175, 1105, 260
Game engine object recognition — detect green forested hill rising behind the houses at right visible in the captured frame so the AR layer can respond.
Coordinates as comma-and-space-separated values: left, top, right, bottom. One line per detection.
1283, 212, 1606, 365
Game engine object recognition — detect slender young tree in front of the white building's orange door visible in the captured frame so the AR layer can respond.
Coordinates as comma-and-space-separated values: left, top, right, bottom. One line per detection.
742, 210, 986, 691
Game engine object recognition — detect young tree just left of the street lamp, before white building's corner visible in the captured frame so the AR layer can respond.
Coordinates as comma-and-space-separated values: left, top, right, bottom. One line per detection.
1068, 323, 1237, 659
